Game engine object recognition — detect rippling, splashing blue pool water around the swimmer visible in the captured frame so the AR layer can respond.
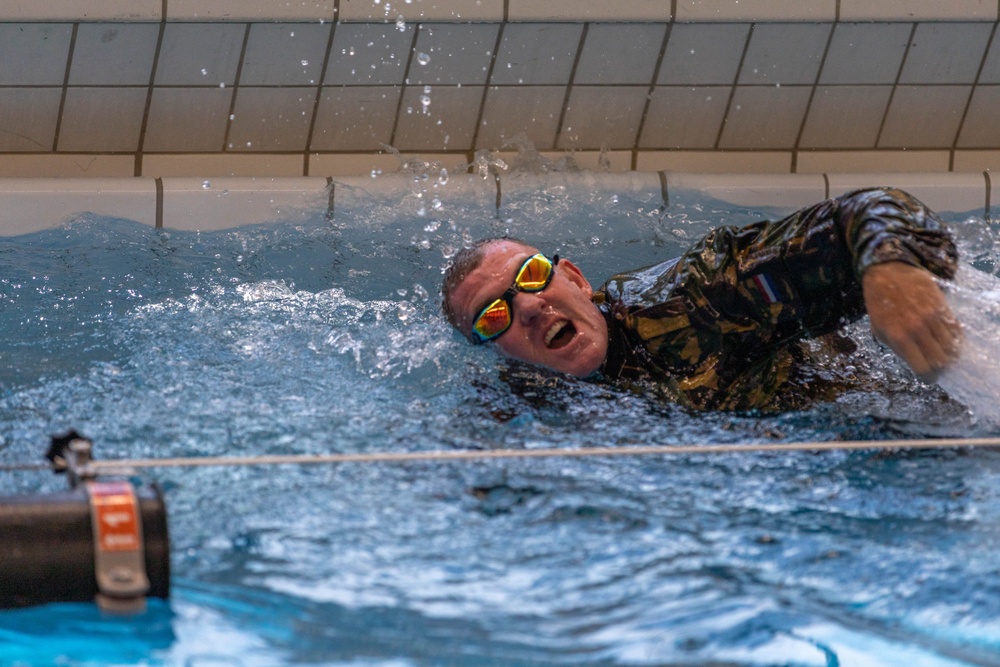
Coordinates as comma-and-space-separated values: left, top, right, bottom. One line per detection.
0, 175, 1000, 667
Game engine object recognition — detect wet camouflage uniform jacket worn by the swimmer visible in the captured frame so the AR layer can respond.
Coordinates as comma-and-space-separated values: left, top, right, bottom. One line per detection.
594, 189, 958, 409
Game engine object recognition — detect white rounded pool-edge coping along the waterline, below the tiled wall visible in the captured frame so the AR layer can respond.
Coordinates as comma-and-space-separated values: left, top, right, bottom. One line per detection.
0, 169, 992, 236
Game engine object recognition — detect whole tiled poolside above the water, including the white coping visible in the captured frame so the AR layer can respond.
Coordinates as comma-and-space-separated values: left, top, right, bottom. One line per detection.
0, 0, 1000, 230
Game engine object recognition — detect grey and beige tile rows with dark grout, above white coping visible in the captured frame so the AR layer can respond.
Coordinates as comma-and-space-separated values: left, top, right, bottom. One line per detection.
0, 12, 1000, 183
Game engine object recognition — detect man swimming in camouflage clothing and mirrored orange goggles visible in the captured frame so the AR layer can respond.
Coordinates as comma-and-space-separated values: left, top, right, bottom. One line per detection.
442, 188, 961, 409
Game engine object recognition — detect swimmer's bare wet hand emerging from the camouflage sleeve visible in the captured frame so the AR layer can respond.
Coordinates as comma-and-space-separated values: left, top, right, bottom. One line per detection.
861, 262, 962, 382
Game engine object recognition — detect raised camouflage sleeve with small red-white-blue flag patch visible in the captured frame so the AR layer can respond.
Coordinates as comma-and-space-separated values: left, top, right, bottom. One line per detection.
682, 189, 958, 342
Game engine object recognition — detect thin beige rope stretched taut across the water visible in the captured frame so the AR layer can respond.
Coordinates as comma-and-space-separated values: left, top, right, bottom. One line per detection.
0, 437, 1000, 473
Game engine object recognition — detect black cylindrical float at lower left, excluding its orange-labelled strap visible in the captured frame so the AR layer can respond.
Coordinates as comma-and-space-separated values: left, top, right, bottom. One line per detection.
0, 486, 170, 608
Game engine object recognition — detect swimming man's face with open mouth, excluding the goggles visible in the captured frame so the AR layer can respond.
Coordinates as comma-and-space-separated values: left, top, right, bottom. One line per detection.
451, 241, 608, 377
